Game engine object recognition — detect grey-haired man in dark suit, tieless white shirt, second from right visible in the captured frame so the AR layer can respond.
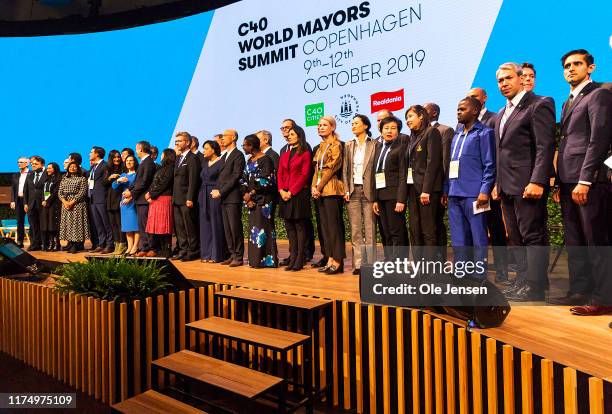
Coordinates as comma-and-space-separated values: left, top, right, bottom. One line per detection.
492, 63, 555, 301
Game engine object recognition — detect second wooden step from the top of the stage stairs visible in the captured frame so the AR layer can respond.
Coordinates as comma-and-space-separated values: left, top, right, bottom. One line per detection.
187, 316, 309, 351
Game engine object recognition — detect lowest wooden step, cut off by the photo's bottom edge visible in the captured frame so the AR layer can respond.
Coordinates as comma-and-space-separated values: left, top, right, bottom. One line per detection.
113, 390, 206, 414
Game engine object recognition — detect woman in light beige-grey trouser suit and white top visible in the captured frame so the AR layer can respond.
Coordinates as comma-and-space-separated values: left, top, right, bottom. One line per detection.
342, 114, 376, 275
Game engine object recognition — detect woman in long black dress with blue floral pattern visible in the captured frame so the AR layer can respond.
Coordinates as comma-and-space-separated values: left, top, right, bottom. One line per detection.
240, 134, 278, 268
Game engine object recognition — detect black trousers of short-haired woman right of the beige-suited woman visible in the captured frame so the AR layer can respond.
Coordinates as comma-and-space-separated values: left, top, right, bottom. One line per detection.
378, 200, 409, 260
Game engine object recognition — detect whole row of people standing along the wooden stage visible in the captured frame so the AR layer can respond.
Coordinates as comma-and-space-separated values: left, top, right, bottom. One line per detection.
9, 49, 612, 314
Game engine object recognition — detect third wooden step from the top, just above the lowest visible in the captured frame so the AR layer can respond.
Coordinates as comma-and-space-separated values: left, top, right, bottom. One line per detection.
153, 350, 283, 399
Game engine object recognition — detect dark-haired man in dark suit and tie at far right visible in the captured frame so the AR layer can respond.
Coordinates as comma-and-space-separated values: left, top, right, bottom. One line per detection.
550, 49, 612, 315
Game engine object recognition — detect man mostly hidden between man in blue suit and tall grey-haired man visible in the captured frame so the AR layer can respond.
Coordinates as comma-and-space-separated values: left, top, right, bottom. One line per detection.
468, 87, 511, 286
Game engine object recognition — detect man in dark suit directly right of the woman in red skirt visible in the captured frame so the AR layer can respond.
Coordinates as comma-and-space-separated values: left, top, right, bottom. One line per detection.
172, 132, 200, 262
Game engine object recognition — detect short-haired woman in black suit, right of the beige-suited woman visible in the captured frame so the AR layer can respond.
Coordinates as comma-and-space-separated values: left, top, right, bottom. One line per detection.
370, 116, 408, 260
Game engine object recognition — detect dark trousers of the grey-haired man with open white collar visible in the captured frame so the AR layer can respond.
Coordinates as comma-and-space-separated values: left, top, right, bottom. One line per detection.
502, 191, 550, 289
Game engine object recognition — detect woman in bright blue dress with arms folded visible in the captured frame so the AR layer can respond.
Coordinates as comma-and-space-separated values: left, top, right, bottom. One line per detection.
113, 155, 140, 256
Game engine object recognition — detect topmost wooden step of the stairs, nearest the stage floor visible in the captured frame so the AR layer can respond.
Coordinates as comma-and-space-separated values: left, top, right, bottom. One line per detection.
215, 288, 331, 311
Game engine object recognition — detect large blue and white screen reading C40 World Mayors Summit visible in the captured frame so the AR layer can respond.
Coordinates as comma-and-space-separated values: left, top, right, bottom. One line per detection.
0, 0, 612, 172
